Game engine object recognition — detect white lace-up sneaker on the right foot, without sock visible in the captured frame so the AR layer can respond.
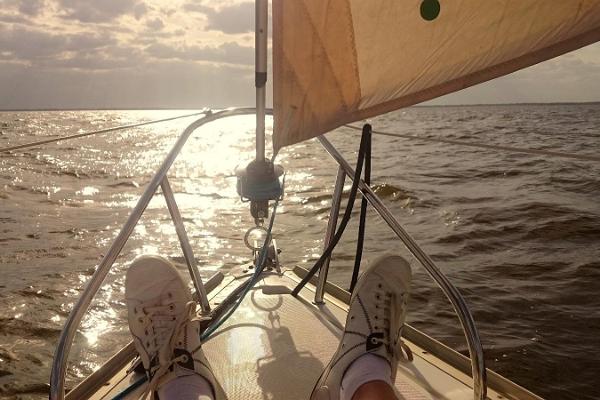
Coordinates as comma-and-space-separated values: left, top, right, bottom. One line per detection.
311, 255, 411, 400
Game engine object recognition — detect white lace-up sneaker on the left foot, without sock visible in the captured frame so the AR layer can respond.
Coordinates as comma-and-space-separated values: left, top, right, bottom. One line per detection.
125, 256, 226, 400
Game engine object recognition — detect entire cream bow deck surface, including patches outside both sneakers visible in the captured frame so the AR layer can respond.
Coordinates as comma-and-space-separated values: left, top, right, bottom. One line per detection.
93, 272, 506, 400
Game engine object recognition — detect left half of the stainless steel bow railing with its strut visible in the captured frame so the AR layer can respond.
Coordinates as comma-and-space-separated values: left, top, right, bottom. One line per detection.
50, 108, 270, 400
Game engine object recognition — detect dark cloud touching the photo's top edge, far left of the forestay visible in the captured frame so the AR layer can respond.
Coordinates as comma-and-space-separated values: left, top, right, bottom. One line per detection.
58, 0, 147, 22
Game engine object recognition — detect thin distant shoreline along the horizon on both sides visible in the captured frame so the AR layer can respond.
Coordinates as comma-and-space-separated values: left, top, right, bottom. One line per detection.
0, 100, 600, 112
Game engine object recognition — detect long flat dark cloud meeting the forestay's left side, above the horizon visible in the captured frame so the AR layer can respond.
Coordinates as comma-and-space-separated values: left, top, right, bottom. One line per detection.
146, 42, 254, 65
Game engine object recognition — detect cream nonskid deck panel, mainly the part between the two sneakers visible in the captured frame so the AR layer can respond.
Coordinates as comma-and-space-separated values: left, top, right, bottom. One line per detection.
204, 277, 436, 400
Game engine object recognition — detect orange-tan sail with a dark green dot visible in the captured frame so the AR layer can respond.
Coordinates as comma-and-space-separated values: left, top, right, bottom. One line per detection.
273, 0, 600, 151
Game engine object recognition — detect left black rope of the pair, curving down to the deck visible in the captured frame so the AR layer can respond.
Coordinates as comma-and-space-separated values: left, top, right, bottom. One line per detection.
292, 124, 371, 297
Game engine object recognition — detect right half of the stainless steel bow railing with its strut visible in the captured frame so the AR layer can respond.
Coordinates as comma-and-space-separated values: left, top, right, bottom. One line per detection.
315, 136, 487, 400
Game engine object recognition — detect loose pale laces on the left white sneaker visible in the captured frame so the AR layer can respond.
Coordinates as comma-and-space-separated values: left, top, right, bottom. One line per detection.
141, 301, 196, 399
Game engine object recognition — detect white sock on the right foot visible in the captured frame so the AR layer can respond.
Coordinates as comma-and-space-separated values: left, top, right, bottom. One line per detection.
340, 354, 394, 400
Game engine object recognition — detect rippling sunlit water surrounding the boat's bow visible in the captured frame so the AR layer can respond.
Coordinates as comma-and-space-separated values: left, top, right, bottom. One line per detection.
0, 104, 600, 399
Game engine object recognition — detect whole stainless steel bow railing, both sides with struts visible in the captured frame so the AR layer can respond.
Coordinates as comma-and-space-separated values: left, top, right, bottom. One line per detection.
50, 108, 487, 400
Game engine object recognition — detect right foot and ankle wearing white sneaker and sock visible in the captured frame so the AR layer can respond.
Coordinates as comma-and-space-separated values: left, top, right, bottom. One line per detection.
311, 255, 411, 400
